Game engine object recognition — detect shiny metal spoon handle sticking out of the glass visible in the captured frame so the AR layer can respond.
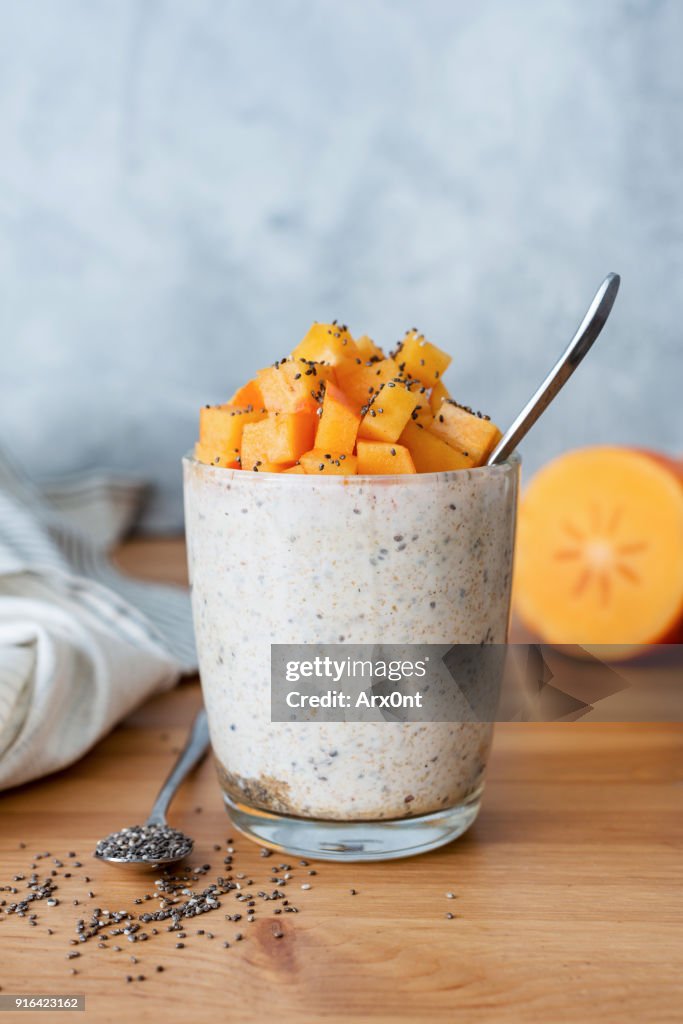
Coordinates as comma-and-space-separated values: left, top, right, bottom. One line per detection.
486, 273, 621, 466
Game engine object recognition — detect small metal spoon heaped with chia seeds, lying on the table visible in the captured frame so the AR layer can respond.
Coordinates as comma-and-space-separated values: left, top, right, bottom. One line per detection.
93, 709, 210, 867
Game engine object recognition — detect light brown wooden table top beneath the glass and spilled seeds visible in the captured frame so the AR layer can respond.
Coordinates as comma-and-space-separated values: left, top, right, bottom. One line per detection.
0, 542, 683, 1024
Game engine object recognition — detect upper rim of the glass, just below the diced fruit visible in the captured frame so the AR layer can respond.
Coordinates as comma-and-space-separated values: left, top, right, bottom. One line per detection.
182, 451, 522, 487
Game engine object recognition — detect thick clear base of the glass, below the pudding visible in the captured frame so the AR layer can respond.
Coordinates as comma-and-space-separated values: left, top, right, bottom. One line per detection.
223, 788, 481, 861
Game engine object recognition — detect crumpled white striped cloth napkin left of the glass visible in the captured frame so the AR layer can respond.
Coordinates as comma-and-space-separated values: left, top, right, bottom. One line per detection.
0, 453, 197, 790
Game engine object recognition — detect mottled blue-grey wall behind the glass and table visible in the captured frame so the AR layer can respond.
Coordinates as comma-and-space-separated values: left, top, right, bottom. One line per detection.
0, 0, 683, 529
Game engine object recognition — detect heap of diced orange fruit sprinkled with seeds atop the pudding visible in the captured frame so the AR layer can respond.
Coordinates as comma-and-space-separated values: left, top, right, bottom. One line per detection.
195, 323, 498, 475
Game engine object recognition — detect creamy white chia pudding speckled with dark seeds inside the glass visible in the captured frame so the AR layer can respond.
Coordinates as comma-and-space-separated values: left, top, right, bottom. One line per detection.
183, 458, 518, 822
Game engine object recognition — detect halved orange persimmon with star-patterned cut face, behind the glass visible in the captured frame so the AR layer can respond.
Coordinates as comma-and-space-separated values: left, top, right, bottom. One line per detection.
514, 446, 683, 659
